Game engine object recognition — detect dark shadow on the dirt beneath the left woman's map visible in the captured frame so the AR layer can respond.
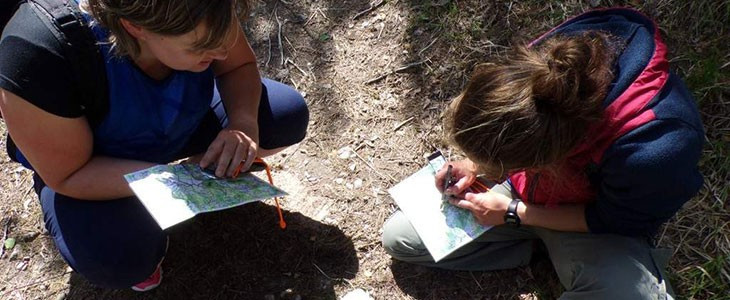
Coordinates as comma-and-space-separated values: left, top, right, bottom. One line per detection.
67, 203, 358, 299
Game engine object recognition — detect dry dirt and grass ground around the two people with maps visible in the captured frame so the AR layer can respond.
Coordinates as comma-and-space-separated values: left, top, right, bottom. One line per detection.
0, 0, 730, 299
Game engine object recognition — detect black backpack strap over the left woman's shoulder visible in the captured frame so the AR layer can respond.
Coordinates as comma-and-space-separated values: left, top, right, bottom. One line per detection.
28, 0, 109, 128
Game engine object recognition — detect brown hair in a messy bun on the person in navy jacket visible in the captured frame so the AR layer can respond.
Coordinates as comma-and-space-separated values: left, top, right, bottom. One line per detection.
446, 32, 615, 178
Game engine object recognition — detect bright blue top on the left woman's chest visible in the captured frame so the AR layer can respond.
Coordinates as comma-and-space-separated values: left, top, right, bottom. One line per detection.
86, 16, 214, 163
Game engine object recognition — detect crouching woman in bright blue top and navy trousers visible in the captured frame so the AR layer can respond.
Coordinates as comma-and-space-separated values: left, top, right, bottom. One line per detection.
0, 0, 309, 291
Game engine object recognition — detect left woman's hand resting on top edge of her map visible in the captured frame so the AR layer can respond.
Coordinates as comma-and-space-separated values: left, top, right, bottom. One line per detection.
200, 129, 258, 177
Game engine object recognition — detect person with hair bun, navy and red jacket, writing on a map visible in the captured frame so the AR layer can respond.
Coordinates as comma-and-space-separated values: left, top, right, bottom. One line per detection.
383, 9, 704, 299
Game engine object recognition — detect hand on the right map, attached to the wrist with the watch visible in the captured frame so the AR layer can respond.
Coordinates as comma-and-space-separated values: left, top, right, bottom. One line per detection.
449, 192, 512, 225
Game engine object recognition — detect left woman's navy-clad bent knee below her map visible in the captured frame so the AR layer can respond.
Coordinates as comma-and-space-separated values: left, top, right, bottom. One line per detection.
41, 192, 167, 288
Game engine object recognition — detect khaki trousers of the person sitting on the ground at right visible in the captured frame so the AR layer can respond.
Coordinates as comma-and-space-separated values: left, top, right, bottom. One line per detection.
383, 184, 673, 300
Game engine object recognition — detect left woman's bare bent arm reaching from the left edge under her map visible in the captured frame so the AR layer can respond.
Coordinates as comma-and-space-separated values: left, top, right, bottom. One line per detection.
0, 89, 154, 200
